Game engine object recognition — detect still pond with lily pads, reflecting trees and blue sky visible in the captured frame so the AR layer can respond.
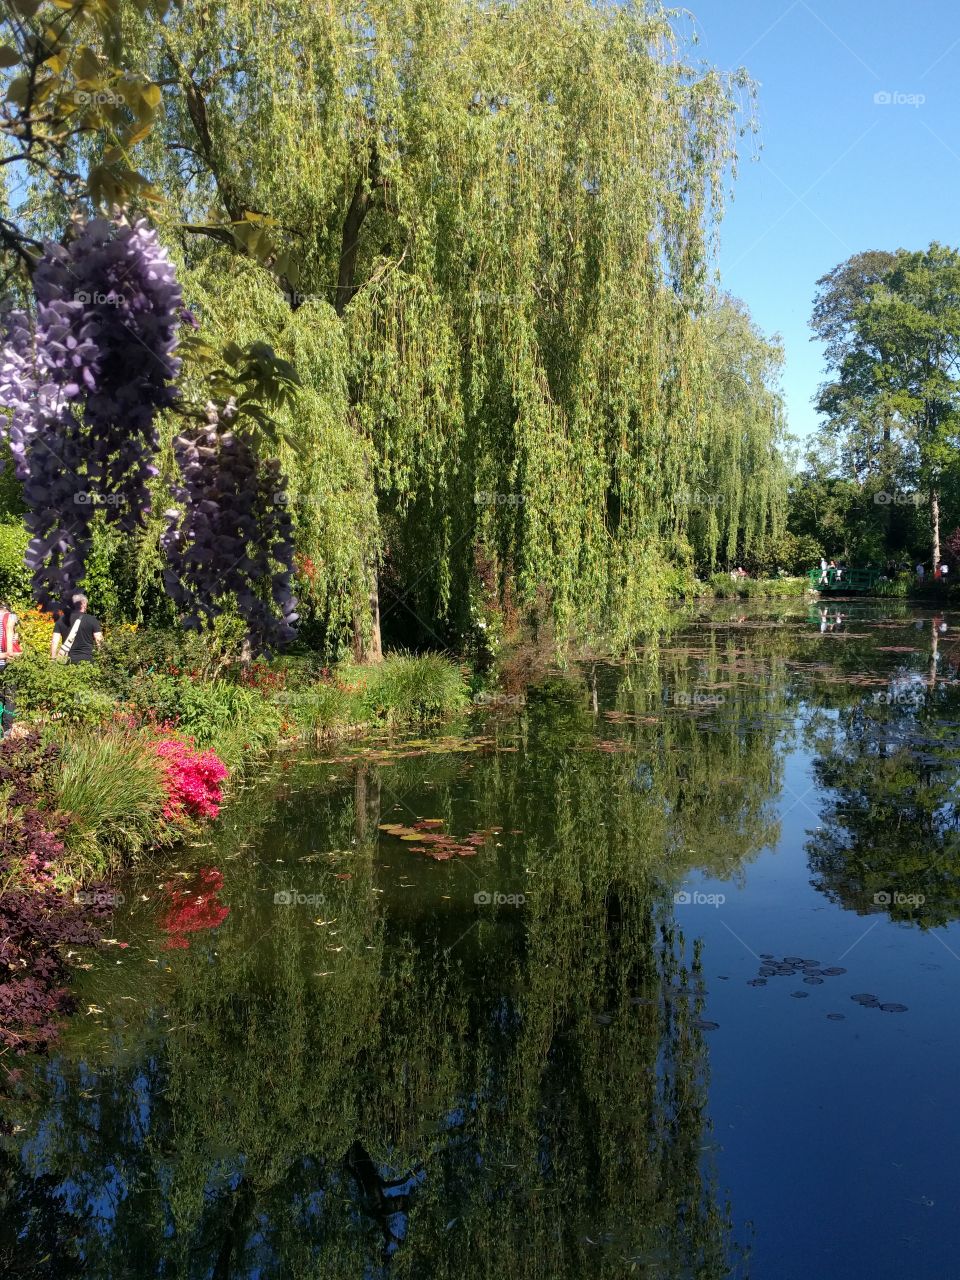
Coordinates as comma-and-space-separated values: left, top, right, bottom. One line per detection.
0, 600, 960, 1280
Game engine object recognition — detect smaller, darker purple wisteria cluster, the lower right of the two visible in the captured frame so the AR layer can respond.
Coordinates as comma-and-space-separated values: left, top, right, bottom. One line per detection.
163, 406, 297, 653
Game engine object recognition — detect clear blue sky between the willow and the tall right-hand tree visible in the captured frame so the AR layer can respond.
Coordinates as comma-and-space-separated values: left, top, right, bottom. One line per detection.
689, 0, 960, 450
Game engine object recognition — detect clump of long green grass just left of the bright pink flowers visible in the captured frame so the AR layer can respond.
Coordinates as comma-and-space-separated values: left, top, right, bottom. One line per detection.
45, 726, 177, 878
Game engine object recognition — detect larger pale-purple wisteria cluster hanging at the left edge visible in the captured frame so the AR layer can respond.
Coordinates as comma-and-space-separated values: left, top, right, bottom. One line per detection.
0, 219, 183, 604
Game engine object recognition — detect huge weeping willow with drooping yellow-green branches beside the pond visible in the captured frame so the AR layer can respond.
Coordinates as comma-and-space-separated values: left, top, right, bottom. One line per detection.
97, 0, 777, 655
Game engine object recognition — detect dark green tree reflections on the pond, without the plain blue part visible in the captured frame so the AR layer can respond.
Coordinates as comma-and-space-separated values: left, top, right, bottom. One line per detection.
0, 607, 960, 1280
